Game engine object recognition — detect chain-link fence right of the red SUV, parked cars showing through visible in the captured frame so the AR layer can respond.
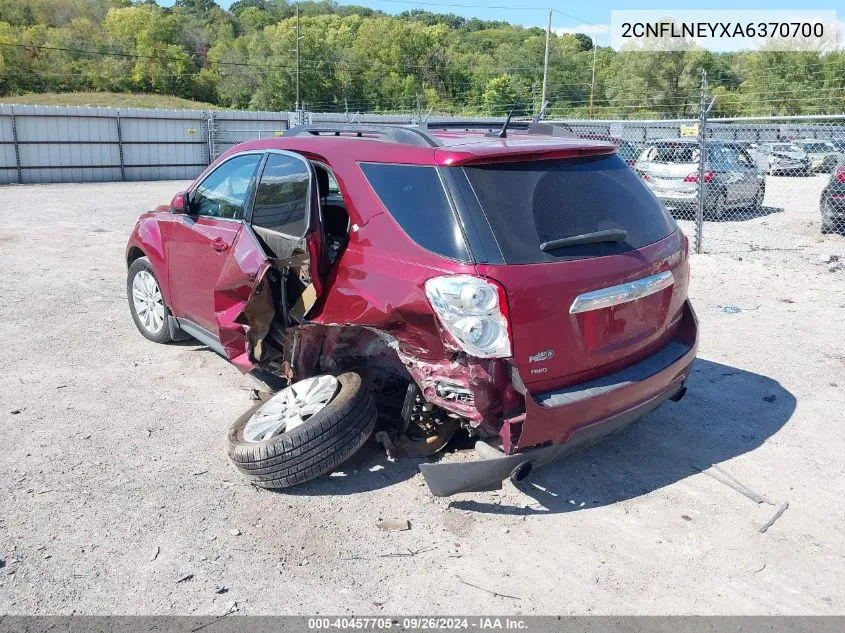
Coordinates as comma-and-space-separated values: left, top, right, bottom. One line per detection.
544, 113, 845, 252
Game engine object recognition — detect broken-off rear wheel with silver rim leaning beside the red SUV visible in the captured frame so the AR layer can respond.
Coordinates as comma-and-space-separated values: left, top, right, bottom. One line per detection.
226, 373, 376, 488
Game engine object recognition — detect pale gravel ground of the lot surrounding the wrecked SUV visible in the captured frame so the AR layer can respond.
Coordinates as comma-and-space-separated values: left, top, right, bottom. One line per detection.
0, 177, 845, 614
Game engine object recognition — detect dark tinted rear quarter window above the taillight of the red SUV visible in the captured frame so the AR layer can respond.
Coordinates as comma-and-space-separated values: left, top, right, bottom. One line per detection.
361, 163, 469, 261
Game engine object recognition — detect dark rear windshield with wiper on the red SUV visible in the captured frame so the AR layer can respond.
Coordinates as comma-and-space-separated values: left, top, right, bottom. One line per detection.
463, 155, 677, 264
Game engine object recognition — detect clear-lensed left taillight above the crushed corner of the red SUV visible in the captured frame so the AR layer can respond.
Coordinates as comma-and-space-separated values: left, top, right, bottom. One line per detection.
425, 275, 511, 358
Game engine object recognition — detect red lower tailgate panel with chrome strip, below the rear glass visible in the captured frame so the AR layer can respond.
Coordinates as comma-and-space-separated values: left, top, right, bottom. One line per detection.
479, 231, 689, 393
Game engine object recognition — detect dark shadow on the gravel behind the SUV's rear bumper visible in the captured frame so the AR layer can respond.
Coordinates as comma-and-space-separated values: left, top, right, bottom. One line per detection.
450, 359, 795, 515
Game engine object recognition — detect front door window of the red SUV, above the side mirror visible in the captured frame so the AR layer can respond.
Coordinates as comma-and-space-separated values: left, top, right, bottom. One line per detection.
191, 154, 261, 220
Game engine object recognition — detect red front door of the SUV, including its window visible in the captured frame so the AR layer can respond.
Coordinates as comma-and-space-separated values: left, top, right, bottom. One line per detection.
165, 153, 262, 338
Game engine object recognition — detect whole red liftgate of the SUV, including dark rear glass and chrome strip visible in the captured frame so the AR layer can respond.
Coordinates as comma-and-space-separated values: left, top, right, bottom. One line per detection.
464, 156, 688, 391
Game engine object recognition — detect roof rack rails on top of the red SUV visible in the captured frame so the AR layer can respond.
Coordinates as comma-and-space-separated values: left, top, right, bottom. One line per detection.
285, 121, 576, 147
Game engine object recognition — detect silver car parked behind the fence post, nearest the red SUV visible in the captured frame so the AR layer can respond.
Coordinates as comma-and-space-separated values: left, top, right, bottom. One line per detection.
634, 139, 766, 219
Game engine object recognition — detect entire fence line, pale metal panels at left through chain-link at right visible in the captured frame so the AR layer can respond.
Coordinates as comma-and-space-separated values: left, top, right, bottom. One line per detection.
0, 100, 845, 252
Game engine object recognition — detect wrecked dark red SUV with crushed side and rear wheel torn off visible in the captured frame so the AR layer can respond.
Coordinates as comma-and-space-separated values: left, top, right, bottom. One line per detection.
126, 123, 698, 495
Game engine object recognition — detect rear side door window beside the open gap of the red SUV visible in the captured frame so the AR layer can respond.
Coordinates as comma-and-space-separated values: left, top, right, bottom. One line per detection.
252, 154, 311, 237
